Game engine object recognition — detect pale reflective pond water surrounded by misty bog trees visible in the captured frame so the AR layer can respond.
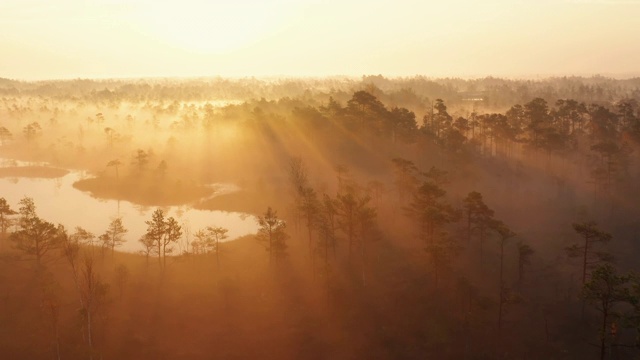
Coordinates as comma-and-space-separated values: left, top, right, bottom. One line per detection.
0, 167, 257, 252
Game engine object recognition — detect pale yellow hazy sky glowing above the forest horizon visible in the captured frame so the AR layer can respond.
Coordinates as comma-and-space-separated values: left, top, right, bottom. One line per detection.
0, 0, 640, 80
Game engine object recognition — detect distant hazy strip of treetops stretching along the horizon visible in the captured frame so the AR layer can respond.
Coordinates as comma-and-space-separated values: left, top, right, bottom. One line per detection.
0, 75, 640, 108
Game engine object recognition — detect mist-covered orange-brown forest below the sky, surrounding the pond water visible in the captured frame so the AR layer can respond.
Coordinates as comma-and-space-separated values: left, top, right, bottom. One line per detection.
0, 75, 640, 359
